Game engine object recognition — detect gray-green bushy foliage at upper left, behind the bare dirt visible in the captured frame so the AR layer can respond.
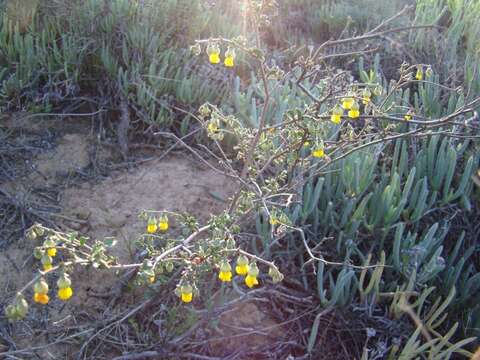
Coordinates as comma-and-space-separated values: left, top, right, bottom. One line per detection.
0, 0, 244, 121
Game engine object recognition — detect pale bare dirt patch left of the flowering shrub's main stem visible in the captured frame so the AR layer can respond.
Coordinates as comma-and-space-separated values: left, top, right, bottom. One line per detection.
61, 156, 236, 261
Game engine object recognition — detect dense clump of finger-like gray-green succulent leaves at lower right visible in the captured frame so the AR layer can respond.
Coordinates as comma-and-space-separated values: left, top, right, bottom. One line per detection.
257, 131, 480, 359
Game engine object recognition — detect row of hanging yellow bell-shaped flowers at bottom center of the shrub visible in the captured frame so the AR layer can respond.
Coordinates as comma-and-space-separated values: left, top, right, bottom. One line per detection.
176, 255, 283, 303
